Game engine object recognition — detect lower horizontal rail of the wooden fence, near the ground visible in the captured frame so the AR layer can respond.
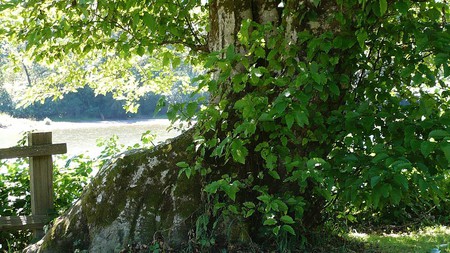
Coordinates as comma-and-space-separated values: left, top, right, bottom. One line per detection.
0, 215, 50, 230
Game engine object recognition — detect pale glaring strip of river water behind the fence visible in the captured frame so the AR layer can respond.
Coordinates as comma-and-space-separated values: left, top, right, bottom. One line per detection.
0, 119, 179, 156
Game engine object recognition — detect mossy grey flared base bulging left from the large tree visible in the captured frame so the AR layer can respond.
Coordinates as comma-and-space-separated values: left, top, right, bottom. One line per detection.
25, 131, 201, 252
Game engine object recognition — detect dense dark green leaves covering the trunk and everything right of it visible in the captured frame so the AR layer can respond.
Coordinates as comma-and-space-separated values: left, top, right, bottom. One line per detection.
174, 0, 450, 249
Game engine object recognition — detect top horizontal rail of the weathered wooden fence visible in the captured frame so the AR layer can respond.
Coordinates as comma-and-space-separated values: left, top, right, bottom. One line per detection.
0, 143, 67, 159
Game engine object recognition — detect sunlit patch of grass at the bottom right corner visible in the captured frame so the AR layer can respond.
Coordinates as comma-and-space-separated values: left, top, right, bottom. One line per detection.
348, 226, 450, 253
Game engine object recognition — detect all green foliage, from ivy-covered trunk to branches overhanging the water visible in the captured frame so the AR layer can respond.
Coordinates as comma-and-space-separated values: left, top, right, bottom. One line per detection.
0, 0, 450, 250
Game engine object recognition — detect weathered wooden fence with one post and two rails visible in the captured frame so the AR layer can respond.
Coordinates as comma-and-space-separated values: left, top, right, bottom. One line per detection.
0, 132, 67, 238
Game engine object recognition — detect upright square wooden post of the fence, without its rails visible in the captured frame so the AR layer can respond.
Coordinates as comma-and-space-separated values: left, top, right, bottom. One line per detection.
28, 132, 53, 238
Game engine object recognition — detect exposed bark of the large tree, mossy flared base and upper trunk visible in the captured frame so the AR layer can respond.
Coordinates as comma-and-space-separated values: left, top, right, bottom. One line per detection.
26, 0, 344, 252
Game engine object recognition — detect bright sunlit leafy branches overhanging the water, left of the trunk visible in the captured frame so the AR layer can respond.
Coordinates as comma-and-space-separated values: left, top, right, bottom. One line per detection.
0, 1, 205, 111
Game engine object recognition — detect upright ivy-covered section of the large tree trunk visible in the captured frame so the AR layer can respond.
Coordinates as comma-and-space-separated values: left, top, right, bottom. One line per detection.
193, 1, 355, 237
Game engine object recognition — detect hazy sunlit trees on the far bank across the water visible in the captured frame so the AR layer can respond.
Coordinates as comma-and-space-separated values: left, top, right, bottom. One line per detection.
0, 40, 202, 120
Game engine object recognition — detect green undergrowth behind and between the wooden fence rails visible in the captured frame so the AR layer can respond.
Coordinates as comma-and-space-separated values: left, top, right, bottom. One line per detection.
0, 152, 93, 252
